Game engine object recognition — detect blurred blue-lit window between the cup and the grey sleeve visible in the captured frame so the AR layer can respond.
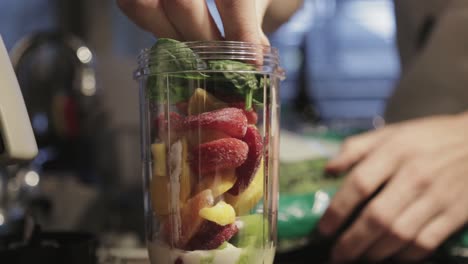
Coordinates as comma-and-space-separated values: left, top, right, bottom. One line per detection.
271, 0, 400, 123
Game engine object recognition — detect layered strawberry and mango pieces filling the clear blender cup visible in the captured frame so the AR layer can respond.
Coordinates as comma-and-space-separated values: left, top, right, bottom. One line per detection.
147, 39, 275, 264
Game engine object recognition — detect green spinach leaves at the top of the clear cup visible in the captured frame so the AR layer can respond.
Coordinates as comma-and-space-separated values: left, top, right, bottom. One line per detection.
146, 38, 269, 110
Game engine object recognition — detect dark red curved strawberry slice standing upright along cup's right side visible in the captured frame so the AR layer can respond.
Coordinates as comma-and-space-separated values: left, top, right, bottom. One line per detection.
228, 125, 263, 195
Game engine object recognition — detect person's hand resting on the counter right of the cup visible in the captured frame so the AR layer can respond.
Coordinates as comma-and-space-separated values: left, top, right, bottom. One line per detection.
319, 114, 468, 263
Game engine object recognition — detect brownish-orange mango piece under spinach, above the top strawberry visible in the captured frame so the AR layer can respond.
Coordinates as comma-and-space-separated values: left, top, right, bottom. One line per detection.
188, 88, 228, 115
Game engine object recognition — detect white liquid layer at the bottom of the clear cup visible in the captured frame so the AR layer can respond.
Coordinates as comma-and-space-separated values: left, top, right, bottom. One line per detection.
148, 241, 275, 264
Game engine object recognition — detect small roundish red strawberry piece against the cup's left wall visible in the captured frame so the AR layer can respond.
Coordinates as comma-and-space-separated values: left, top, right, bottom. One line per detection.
155, 112, 185, 144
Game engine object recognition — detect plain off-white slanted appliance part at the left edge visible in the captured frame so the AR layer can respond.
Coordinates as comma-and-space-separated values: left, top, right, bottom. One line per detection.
0, 36, 37, 165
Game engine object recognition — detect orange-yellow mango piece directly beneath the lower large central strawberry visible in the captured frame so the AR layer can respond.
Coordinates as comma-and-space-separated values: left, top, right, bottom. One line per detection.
197, 169, 237, 197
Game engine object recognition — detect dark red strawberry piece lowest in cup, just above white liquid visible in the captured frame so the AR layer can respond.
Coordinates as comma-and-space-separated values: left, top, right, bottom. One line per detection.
185, 221, 239, 250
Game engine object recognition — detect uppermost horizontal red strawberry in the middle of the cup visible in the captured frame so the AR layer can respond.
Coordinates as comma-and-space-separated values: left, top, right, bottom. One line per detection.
185, 108, 247, 138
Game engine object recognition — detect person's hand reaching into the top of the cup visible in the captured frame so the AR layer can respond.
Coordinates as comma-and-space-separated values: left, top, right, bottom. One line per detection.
117, 0, 271, 45
